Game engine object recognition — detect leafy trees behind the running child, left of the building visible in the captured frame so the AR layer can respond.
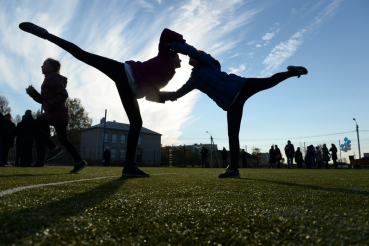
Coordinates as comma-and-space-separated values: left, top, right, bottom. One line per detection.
0, 96, 92, 145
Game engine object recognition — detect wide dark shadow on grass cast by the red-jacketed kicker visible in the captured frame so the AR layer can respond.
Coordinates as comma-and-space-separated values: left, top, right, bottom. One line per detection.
0, 178, 127, 244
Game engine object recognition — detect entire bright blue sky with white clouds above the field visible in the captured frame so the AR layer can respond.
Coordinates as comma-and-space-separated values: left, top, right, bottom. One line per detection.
0, 0, 369, 161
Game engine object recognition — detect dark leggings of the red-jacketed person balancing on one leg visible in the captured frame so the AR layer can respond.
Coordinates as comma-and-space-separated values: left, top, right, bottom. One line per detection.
47, 34, 142, 165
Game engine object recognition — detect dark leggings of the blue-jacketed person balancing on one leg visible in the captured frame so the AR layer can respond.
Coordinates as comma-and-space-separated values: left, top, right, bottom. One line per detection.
227, 71, 298, 169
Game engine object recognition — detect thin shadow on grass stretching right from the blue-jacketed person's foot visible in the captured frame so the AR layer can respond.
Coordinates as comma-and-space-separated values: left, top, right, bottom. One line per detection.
240, 178, 369, 196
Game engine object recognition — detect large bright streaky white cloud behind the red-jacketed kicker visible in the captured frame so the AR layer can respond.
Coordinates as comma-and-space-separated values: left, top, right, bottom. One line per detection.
0, 0, 262, 144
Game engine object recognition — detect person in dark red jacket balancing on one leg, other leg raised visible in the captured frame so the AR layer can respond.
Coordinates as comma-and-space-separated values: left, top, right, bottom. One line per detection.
19, 22, 186, 177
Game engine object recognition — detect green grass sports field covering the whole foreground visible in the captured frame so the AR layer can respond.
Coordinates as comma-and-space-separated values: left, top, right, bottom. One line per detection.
0, 167, 369, 245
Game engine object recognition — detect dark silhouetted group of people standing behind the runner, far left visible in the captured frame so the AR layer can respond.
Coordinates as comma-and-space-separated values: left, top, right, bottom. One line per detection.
0, 108, 50, 167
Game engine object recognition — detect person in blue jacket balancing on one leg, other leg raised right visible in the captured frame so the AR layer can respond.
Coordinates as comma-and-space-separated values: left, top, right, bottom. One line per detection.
161, 42, 308, 178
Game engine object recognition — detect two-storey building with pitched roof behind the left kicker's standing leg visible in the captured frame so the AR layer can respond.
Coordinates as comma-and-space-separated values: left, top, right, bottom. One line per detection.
80, 118, 161, 166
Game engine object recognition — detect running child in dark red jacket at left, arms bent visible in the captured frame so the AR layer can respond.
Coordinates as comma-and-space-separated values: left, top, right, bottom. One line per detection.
26, 58, 87, 173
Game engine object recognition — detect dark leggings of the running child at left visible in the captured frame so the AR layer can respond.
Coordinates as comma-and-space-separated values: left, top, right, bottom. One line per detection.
29, 116, 82, 163
